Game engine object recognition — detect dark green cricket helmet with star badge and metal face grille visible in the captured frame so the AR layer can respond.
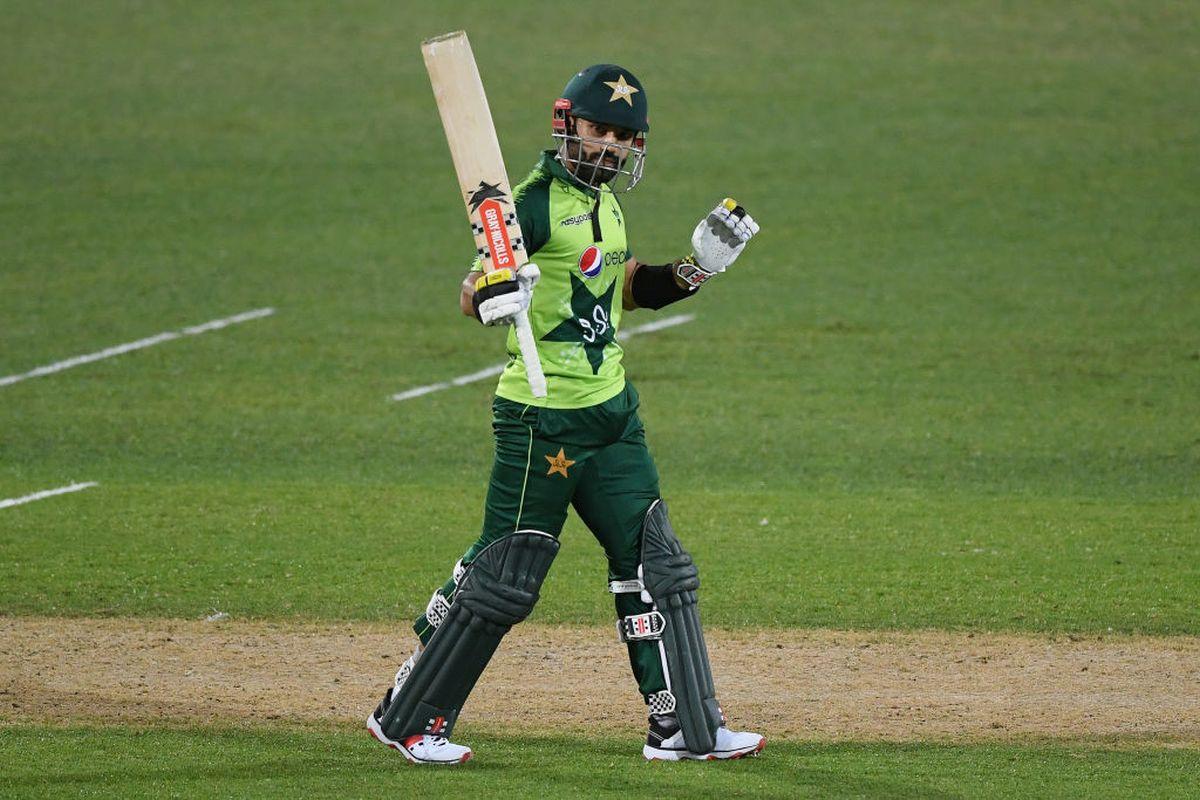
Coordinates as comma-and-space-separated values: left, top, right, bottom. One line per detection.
552, 64, 650, 192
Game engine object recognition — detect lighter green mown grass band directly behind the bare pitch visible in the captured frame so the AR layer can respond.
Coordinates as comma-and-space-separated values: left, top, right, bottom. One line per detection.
0, 482, 1198, 633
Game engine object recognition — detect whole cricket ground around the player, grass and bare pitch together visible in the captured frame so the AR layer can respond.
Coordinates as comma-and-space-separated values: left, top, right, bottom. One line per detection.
0, 1, 1200, 799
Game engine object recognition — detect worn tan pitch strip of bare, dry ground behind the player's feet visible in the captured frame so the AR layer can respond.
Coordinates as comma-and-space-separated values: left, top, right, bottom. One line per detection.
0, 616, 1200, 745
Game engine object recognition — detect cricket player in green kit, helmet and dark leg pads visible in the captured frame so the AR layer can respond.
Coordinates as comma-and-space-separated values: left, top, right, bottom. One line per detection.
367, 64, 766, 764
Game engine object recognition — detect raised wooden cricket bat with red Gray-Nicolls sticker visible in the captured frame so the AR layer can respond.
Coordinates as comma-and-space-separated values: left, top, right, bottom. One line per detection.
421, 30, 546, 397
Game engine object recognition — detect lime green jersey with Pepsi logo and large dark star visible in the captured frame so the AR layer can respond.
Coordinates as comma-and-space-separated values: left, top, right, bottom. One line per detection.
496, 150, 631, 409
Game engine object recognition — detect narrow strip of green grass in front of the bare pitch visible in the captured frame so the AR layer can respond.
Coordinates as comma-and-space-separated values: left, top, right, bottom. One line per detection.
0, 728, 1200, 800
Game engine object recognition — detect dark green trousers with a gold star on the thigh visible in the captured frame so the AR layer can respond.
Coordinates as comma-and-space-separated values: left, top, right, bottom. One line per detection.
413, 384, 667, 694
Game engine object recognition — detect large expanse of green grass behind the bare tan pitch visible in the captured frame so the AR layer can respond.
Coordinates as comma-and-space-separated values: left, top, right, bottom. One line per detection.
0, 2, 1200, 633
